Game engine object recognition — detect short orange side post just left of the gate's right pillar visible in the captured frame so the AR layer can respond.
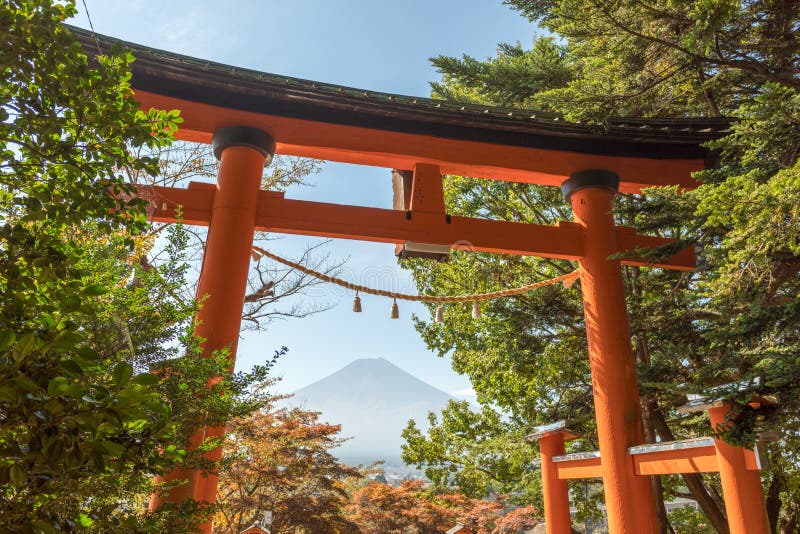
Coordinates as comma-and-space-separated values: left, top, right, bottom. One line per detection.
539, 432, 572, 534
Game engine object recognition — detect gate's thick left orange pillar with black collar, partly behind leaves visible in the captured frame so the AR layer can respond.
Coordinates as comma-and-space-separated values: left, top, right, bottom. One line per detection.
151, 126, 275, 532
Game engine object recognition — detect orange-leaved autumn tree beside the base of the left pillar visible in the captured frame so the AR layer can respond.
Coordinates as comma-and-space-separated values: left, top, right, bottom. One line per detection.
214, 409, 361, 534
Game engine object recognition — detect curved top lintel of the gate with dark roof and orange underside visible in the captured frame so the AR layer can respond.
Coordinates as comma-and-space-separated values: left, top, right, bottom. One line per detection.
70, 27, 729, 191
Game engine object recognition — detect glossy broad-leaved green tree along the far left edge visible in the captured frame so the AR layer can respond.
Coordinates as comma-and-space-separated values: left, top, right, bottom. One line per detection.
0, 1, 176, 532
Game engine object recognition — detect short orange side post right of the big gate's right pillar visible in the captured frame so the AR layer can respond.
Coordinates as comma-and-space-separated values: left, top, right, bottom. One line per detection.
708, 403, 770, 534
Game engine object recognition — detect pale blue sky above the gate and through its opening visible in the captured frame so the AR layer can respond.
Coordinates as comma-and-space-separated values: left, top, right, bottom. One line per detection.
72, 0, 536, 396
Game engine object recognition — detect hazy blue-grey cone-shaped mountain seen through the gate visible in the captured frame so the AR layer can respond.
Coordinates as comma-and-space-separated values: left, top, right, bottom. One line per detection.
288, 358, 454, 464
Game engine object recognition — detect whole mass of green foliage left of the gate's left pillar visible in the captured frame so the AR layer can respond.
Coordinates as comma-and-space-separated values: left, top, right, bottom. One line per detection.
0, 0, 276, 532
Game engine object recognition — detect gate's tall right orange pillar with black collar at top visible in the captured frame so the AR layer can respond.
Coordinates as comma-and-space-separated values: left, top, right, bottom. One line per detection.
561, 170, 658, 534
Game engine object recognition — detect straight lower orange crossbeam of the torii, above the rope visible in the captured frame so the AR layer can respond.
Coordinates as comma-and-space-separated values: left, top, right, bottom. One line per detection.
138, 182, 694, 270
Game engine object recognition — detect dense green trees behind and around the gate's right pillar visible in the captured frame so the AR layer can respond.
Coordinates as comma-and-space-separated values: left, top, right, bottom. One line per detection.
405, 0, 800, 532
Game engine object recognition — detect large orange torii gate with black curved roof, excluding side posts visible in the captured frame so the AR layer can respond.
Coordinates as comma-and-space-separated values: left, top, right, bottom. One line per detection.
73, 29, 767, 534
